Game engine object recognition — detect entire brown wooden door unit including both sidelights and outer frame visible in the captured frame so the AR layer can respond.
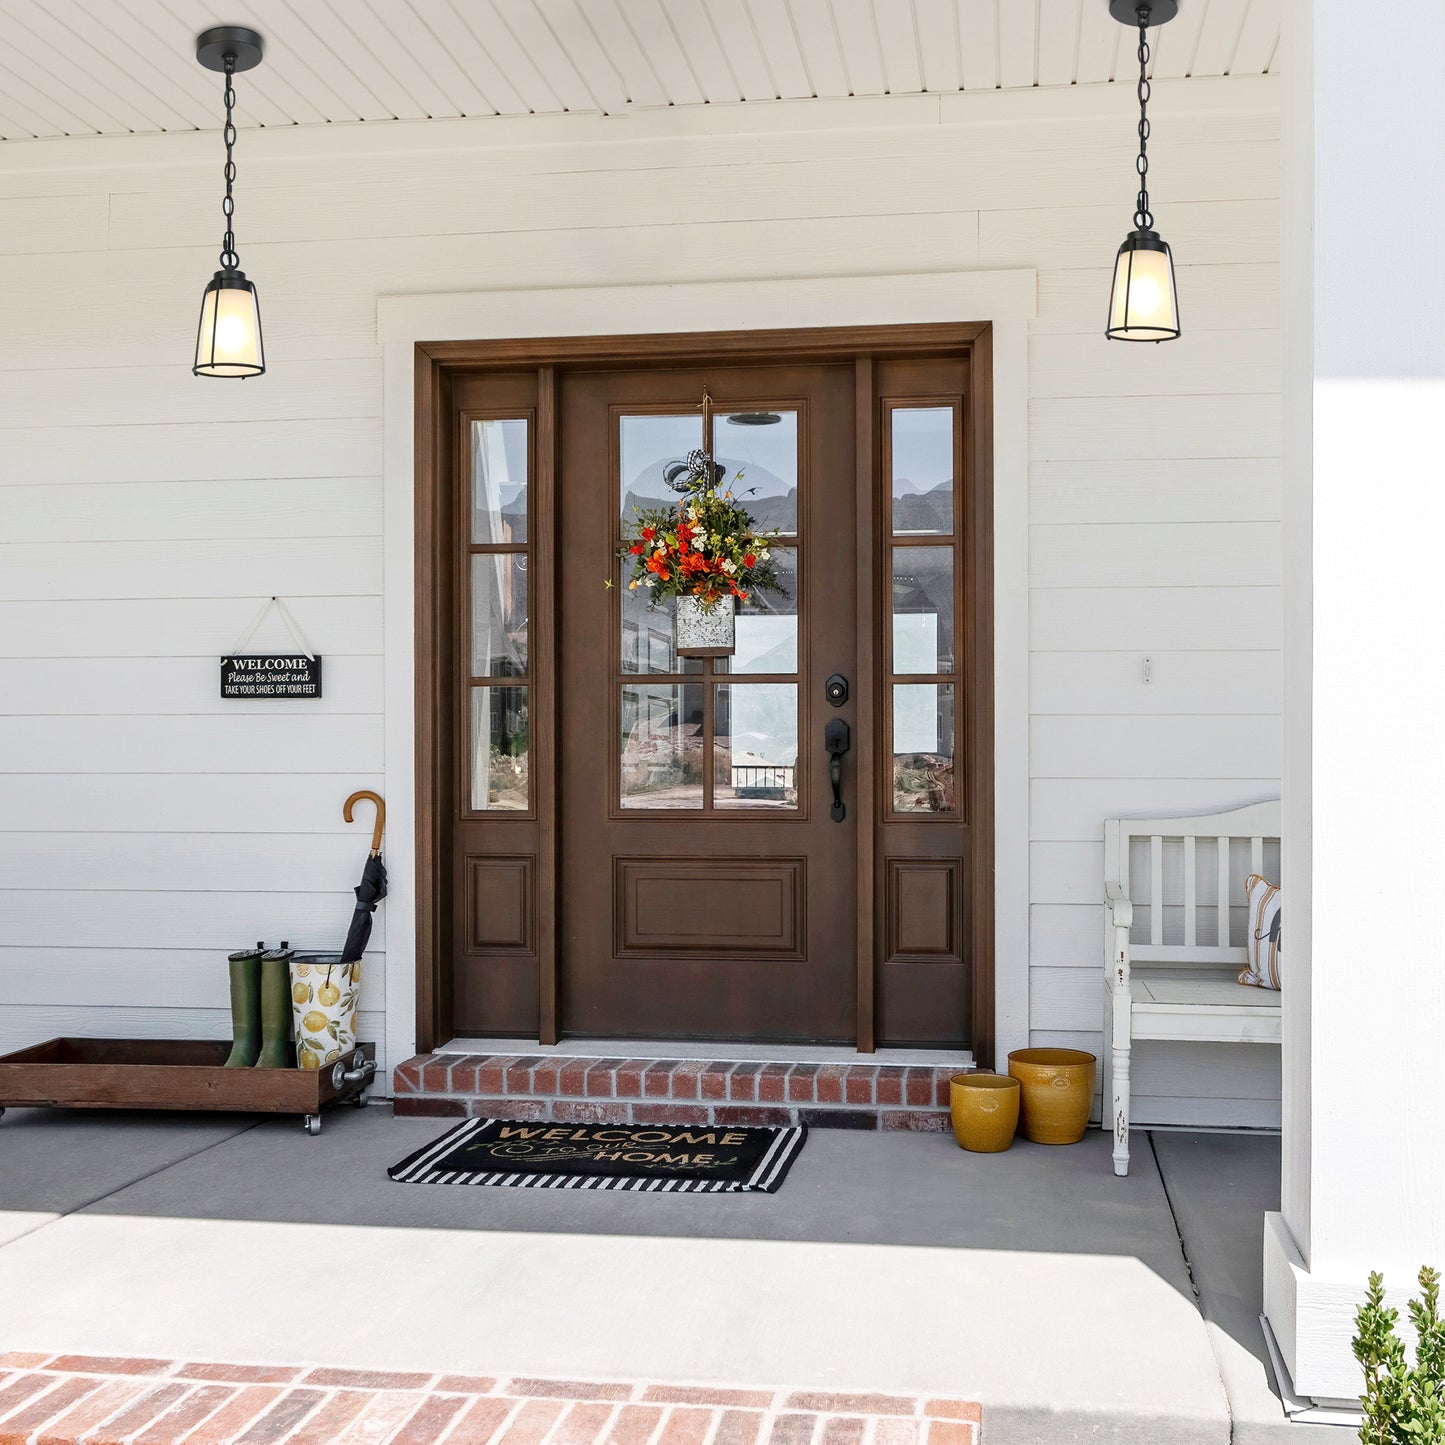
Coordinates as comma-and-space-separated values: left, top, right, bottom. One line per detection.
418, 328, 993, 1062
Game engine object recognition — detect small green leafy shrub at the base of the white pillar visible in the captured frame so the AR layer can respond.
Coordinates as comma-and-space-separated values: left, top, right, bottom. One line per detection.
1353, 1267, 1445, 1445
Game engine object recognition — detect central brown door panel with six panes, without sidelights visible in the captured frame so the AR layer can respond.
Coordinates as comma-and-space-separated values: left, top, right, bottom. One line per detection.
558, 366, 858, 1040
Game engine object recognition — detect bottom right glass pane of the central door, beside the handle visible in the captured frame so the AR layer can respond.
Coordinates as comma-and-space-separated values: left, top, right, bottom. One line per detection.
712, 682, 798, 808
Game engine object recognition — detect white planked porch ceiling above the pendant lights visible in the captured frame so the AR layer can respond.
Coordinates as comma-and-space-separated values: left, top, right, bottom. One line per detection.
0, 0, 1283, 140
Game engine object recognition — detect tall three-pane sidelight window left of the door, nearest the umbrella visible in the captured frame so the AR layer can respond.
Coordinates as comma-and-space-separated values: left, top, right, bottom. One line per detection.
467, 416, 532, 812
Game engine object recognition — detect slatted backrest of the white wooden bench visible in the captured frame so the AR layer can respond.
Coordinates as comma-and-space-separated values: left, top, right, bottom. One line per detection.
1104, 798, 1280, 968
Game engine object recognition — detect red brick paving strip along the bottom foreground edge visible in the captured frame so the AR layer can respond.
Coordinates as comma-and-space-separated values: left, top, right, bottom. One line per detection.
0, 1351, 981, 1445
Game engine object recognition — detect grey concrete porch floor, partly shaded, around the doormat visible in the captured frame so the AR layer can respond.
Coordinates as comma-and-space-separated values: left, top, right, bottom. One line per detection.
0, 1105, 1353, 1445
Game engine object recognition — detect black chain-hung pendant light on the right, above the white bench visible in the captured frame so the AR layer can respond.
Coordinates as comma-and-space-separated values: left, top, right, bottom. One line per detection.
1104, 0, 1179, 341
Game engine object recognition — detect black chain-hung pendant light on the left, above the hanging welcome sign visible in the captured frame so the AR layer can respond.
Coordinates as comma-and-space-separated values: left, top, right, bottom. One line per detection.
191, 25, 266, 379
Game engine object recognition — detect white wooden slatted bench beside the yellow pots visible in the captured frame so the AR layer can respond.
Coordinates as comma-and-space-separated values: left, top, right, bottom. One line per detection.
1104, 799, 1287, 1175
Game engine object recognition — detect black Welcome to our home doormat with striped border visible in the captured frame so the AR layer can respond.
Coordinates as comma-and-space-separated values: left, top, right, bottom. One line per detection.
387, 1118, 808, 1194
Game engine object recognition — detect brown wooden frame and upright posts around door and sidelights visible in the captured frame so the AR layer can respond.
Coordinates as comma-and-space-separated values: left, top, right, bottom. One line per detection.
416, 322, 994, 1061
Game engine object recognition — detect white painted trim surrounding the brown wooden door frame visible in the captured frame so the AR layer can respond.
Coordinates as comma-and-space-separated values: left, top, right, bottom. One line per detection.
387, 269, 1038, 1086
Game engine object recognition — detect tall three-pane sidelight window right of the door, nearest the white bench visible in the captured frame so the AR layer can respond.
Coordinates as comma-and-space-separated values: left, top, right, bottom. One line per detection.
886, 403, 962, 816
